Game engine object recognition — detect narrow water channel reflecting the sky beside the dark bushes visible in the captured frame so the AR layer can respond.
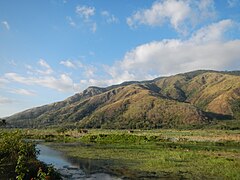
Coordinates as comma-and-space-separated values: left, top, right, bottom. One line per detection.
36, 144, 120, 180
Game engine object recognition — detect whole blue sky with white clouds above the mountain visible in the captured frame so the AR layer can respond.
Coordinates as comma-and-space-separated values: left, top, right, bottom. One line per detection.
0, 0, 240, 117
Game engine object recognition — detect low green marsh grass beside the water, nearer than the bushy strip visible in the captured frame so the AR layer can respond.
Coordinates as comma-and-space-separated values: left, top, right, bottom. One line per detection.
53, 146, 240, 179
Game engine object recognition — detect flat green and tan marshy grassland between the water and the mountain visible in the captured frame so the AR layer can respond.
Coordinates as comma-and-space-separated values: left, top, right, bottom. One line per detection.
26, 130, 240, 179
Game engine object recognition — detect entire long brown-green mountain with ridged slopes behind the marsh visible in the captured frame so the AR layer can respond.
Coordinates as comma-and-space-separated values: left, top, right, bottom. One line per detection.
6, 70, 240, 129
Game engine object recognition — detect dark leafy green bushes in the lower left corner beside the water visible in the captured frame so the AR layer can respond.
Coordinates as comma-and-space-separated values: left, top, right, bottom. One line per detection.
0, 130, 60, 180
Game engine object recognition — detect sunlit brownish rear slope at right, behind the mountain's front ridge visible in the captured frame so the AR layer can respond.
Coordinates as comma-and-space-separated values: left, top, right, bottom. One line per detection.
155, 71, 240, 118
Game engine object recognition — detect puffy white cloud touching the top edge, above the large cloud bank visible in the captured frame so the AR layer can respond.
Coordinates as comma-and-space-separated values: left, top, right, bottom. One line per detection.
127, 0, 215, 33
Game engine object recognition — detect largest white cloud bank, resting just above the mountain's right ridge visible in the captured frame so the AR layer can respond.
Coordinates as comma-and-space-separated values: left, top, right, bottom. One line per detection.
104, 20, 240, 83
